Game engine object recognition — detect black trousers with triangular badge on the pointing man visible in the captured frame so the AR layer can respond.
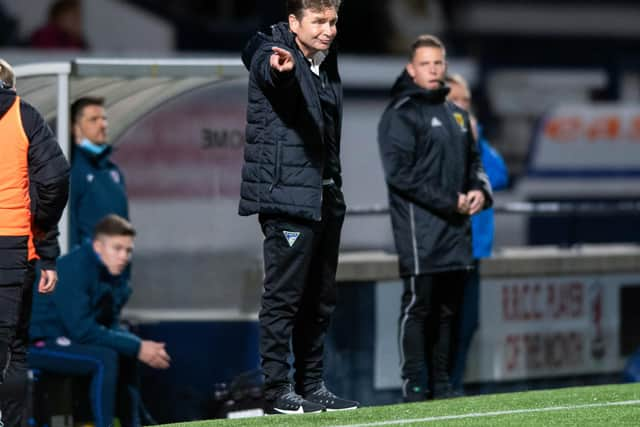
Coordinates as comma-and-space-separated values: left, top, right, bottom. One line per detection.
259, 185, 345, 400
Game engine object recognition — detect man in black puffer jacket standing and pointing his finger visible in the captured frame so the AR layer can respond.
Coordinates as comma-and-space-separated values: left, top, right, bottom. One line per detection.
239, 0, 358, 413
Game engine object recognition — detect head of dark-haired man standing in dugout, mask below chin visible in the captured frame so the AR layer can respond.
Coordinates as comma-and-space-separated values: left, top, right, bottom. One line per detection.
71, 97, 108, 145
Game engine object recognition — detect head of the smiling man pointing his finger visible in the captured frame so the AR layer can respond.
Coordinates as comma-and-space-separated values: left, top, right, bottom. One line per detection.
287, 0, 342, 57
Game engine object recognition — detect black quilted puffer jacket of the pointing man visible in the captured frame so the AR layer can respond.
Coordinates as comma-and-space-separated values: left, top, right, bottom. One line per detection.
239, 23, 342, 221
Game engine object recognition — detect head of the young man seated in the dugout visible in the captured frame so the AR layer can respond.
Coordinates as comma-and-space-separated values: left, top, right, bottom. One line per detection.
93, 214, 136, 276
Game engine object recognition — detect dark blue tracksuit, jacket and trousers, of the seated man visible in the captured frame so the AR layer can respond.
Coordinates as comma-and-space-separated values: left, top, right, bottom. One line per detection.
29, 243, 140, 427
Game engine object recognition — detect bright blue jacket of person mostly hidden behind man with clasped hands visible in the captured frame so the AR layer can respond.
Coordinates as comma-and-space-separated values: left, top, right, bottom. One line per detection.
471, 127, 509, 259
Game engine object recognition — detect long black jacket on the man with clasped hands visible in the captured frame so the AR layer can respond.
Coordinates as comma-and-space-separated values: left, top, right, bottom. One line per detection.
378, 72, 492, 276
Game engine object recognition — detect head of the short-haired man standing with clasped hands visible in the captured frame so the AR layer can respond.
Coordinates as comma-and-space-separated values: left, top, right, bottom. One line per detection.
407, 34, 447, 89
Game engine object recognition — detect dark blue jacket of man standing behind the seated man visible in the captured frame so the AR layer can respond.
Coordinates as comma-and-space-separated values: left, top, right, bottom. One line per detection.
69, 145, 129, 248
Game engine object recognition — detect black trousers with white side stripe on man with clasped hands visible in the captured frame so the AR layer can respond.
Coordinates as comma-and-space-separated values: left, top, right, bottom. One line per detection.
398, 271, 468, 397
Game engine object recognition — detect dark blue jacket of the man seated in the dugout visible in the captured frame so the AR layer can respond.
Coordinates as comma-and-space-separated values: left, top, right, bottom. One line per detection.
29, 244, 140, 357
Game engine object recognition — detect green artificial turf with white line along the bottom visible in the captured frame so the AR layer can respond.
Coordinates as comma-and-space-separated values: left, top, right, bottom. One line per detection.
159, 384, 640, 427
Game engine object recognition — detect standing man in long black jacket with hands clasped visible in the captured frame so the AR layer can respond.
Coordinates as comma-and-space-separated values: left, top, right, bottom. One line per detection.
378, 35, 491, 401
